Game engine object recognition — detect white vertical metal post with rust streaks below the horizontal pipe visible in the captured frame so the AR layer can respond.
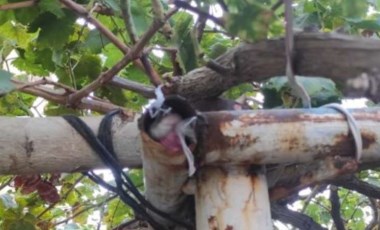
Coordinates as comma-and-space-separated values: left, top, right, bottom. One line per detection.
195, 166, 273, 230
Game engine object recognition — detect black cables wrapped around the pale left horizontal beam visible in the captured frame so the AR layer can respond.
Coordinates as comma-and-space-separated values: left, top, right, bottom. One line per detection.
63, 110, 193, 229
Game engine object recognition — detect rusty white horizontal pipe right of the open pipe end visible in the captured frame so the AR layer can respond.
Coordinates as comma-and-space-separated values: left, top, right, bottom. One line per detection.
197, 108, 380, 165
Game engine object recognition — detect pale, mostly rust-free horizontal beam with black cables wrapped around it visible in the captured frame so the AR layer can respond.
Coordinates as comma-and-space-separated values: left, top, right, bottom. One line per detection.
0, 117, 142, 174
